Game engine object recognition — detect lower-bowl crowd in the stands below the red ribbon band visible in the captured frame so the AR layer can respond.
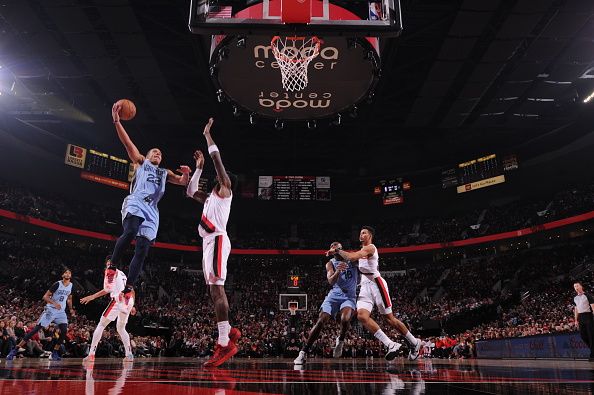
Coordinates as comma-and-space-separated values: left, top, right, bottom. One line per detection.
0, 229, 594, 358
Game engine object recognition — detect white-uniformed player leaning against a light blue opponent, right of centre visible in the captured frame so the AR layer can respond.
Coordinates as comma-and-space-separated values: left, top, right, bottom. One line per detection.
326, 226, 423, 361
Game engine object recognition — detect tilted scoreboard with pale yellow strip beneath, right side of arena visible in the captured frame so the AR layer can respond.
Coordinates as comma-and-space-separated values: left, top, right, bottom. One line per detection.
441, 154, 518, 193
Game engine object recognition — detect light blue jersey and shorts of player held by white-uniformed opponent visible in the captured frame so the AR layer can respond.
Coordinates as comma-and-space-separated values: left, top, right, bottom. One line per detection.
320, 258, 359, 316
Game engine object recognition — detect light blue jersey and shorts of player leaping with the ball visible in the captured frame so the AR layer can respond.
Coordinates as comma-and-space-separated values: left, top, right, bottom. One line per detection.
122, 159, 167, 241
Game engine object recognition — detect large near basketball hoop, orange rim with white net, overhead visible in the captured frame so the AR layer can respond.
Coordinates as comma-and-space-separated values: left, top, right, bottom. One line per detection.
270, 36, 322, 92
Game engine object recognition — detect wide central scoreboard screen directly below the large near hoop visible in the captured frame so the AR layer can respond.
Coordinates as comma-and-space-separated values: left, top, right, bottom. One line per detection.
258, 176, 331, 201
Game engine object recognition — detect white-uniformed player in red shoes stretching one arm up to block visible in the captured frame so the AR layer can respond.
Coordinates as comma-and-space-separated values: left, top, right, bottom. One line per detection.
186, 118, 241, 367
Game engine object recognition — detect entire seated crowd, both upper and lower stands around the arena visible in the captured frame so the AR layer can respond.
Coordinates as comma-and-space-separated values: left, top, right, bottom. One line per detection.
0, 177, 594, 358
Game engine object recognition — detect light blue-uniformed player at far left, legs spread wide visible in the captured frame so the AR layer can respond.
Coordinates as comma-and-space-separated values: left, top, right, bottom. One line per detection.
6, 269, 76, 361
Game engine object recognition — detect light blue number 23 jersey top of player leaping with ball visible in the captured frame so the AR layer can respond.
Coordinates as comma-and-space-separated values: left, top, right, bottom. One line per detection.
127, 159, 167, 210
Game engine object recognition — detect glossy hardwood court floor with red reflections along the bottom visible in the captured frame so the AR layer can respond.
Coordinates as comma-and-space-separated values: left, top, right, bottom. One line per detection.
0, 358, 594, 395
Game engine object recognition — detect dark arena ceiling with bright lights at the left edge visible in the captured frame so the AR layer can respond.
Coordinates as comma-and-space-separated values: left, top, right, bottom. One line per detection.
0, 0, 594, 176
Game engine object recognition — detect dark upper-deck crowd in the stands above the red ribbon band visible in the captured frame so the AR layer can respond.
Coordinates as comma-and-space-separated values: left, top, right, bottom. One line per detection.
0, 180, 594, 249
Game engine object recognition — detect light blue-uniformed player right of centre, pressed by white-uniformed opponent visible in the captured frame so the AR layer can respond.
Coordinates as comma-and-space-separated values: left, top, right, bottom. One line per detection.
293, 241, 359, 365
